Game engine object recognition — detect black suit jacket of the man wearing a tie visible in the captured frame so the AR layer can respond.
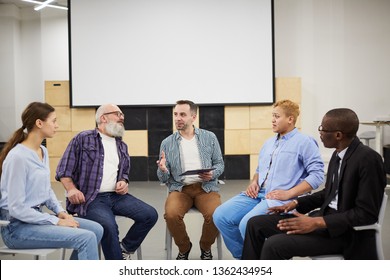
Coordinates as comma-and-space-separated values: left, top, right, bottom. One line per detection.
297, 137, 386, 259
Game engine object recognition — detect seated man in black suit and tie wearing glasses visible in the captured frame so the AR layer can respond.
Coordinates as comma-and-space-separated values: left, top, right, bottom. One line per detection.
242, 108, 386, 260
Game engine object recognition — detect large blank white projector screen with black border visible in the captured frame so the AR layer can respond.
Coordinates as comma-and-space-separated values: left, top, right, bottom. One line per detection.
68, 0, 274, 107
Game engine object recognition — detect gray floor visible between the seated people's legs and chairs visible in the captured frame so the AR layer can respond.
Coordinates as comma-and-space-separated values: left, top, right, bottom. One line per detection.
0, 180, 390, 260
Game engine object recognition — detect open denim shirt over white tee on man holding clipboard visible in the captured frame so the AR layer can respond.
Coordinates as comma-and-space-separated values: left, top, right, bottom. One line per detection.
157, 128, 225, 193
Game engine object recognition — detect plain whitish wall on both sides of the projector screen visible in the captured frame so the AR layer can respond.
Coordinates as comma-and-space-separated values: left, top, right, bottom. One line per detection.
0, 0, 390, 170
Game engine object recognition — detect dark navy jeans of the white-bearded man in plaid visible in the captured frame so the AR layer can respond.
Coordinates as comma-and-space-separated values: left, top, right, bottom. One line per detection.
83, 192, 158, 260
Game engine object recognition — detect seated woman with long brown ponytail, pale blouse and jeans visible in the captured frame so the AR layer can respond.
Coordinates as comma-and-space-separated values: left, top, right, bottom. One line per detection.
0, 102, 103, 260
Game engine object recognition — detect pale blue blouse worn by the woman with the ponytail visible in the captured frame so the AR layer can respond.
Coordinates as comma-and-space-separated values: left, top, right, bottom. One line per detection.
0, 144, 65, 225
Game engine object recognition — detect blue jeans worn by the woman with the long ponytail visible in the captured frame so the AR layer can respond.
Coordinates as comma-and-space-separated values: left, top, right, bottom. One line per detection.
1, 214, 103, 260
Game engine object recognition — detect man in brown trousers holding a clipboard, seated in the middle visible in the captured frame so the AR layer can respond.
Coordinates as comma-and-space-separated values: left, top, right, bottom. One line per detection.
157, 100, 224, 260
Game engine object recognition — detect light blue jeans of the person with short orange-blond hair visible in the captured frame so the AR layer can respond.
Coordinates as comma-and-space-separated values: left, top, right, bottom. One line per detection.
213, 188, 268, 259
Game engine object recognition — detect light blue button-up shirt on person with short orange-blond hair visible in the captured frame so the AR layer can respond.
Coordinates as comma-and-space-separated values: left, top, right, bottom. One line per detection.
256, 128, 324, 207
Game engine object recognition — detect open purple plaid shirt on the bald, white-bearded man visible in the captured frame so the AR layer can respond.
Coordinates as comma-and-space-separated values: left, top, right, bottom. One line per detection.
56, 129, 130, 216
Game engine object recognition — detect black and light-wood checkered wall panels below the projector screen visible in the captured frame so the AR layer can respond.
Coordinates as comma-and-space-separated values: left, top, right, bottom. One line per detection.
45, 78, 301, 181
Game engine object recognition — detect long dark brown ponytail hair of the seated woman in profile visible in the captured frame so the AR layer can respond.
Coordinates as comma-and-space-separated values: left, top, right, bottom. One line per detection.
0, 102, 54, 176
